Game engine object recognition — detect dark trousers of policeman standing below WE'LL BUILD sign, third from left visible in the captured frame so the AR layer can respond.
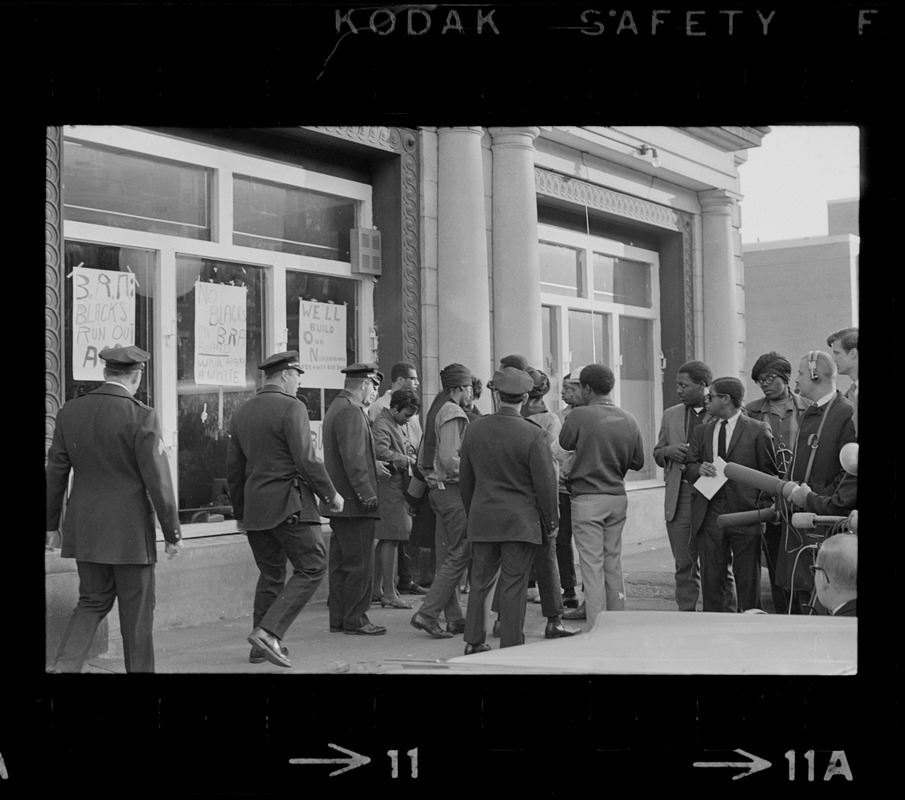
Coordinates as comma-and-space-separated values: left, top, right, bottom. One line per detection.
327, 517, 377, 631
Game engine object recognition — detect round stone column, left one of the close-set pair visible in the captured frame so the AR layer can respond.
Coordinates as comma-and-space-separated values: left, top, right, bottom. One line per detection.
437, 128, 492, 394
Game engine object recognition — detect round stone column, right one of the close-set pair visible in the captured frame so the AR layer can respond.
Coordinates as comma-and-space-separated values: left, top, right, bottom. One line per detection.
489, 127, 544, 369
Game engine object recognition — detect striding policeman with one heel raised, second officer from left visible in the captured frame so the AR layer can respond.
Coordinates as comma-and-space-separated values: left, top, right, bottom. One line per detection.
226, 350, 343, 667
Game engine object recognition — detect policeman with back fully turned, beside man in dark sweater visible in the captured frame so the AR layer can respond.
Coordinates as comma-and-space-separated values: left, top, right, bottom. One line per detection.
459, 367, 571, 655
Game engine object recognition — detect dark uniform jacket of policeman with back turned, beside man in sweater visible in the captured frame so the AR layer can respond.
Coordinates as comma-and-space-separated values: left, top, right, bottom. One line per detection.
459, 406, 559, 544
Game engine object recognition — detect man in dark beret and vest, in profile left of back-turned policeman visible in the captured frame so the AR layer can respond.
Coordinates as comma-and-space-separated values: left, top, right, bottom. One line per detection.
411, 364, 472, 639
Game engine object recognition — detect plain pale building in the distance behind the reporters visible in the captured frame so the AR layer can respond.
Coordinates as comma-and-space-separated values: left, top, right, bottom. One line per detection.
742, 199, 861, 398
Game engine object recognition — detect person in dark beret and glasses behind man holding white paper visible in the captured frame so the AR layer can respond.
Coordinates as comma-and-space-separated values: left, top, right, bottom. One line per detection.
745, 350, 811, 614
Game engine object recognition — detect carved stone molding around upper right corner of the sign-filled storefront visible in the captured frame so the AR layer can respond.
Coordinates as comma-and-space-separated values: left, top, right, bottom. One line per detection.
306, 126, 421, 364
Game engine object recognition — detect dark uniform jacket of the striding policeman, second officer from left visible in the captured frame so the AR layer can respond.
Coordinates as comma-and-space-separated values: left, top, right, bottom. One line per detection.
226, 385, 336, 531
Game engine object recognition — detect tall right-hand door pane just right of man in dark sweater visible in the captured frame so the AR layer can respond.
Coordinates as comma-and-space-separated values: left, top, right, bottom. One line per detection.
619, 316, 656, 481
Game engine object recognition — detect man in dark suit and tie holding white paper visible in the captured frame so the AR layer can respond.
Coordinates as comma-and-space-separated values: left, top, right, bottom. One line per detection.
685, 378, 778, 611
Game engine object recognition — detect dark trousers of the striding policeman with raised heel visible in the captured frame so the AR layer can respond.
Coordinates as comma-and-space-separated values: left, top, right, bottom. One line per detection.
248, 522, 327, 639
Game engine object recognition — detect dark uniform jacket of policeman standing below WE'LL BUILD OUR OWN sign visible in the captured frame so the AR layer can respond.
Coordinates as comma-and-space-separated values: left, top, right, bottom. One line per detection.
321, 389, 380, 519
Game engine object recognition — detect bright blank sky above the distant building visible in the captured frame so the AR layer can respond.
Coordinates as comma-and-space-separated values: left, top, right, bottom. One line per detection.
739, 125, 860, 244
